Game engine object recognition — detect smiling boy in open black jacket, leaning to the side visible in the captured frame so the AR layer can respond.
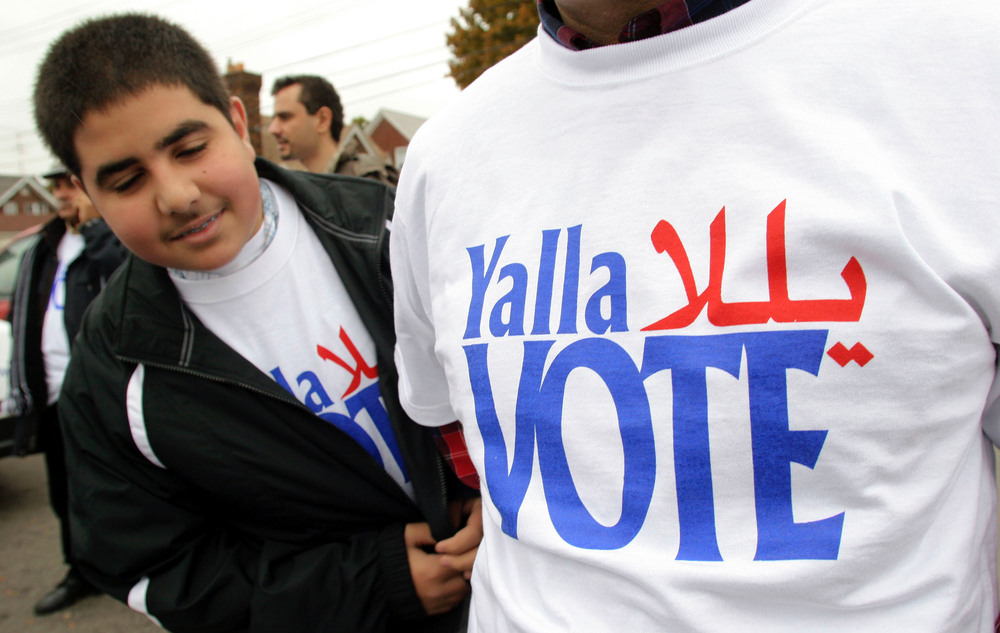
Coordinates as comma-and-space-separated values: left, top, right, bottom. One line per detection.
35, 15, 479, 632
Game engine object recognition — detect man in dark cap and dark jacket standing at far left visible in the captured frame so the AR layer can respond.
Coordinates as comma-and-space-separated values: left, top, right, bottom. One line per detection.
5, 164, 126, 615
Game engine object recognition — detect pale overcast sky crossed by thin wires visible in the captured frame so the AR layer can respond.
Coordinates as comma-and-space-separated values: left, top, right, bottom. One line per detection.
0, 0, 467, 175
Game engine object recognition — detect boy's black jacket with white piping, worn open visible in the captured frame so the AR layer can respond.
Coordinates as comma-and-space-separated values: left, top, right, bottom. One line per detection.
59, 159, 472, 633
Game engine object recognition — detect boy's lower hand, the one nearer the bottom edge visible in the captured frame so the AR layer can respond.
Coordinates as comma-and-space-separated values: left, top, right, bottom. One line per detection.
403, 523, 469, 615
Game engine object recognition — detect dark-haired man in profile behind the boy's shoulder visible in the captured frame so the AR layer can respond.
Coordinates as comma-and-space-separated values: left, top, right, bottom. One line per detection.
267, 75, 397, 186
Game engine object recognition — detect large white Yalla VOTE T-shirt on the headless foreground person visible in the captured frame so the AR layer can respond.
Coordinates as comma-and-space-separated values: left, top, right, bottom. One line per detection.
391, 0, 1000, 633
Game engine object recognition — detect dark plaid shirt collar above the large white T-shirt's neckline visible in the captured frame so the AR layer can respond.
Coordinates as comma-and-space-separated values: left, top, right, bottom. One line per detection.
538, 0, 747, 51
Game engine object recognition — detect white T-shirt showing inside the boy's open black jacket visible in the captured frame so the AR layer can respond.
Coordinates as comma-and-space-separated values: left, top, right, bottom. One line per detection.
171, 181, 414, 498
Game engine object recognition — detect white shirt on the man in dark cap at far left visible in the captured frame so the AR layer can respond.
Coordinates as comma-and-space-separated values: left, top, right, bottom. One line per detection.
42, 231, 84, 405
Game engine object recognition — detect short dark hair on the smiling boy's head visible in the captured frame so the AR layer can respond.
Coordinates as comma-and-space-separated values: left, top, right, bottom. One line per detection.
34, 13, 232, 176
